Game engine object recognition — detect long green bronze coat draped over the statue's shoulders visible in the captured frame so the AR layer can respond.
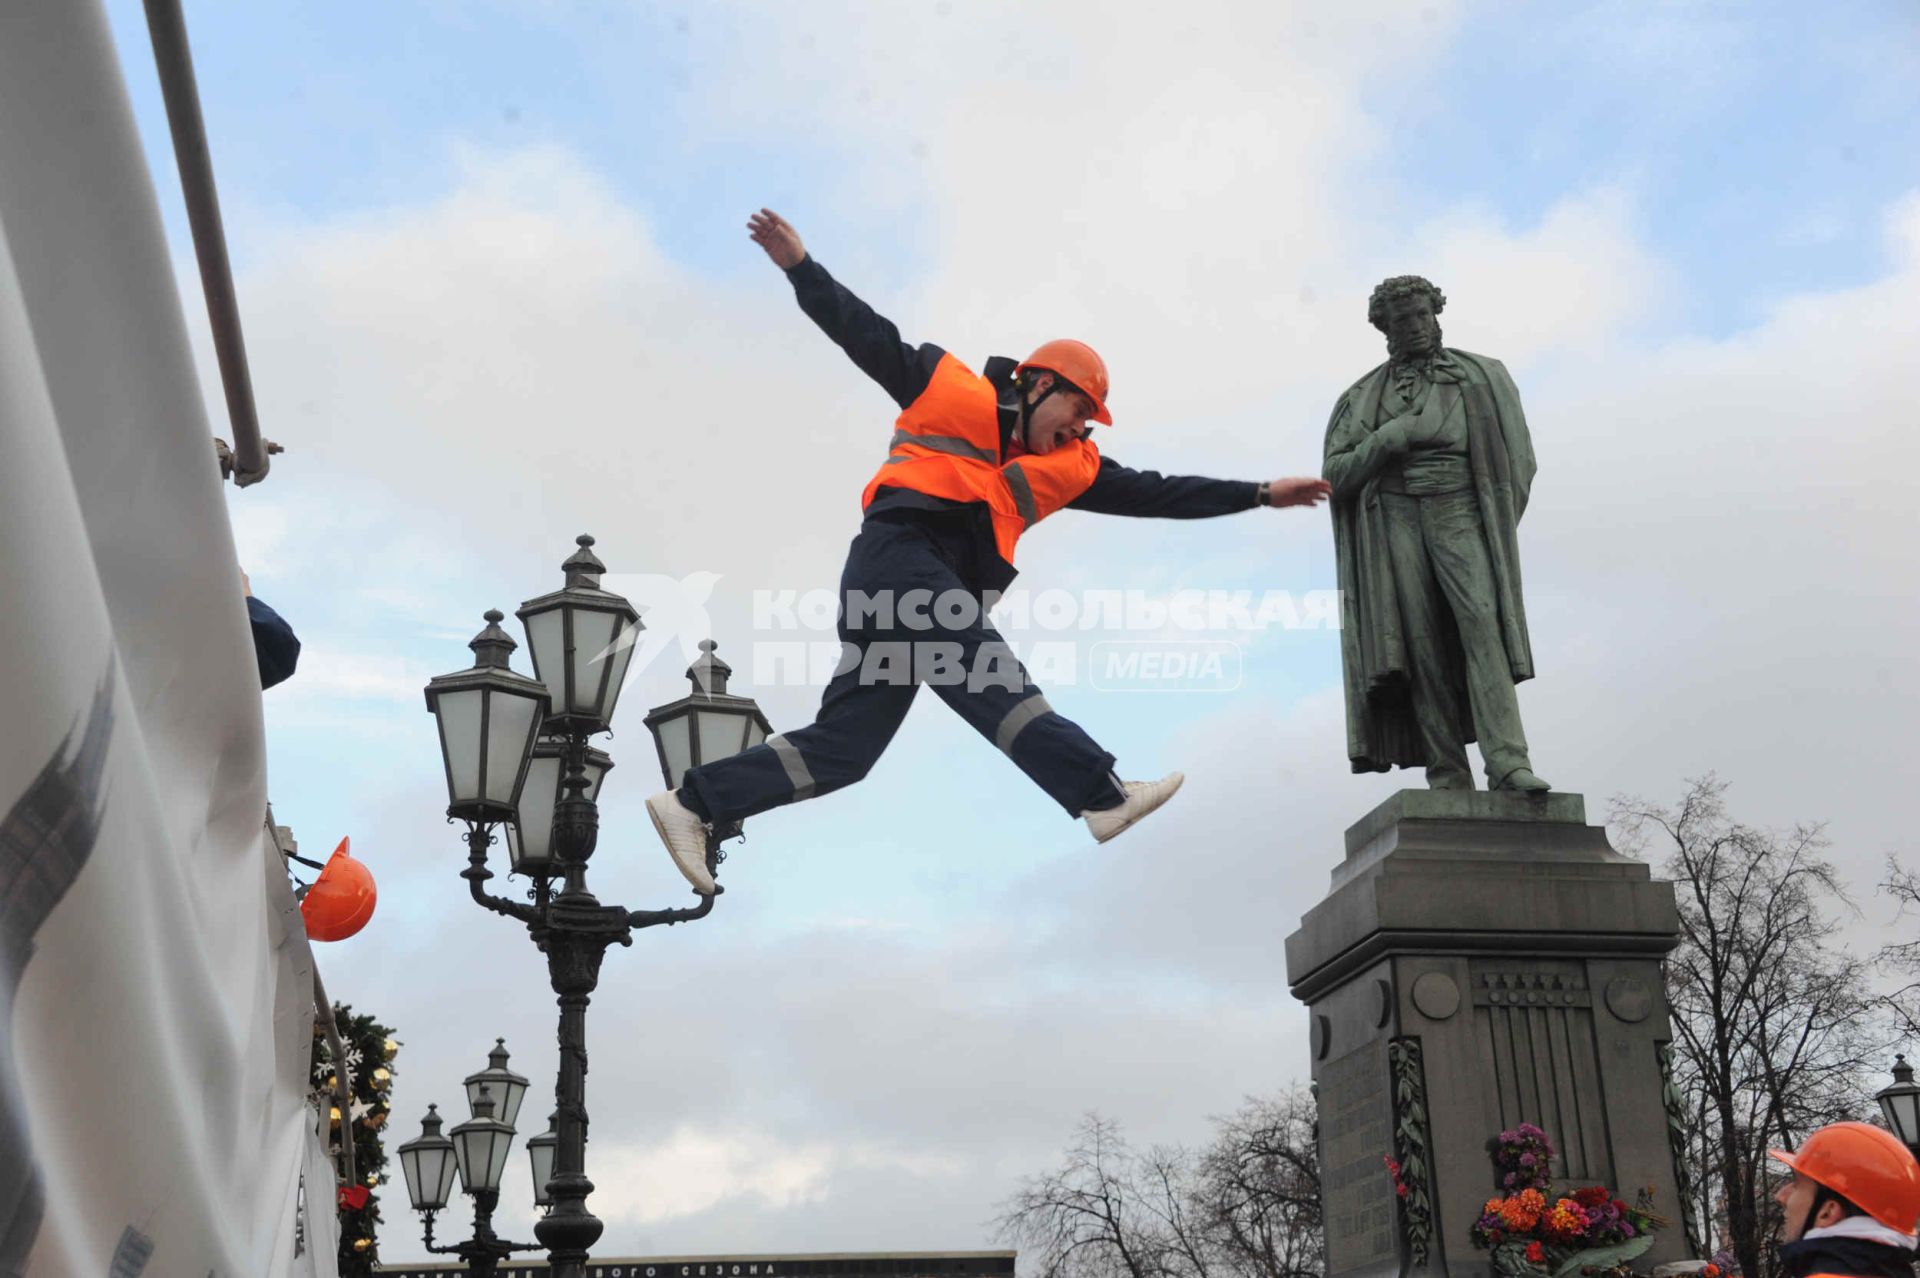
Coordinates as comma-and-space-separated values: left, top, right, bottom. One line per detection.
1325, 347, 1534, 771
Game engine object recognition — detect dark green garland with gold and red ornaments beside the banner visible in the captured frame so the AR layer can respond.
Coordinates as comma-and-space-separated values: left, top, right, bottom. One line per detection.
309, 1004, 399, 1278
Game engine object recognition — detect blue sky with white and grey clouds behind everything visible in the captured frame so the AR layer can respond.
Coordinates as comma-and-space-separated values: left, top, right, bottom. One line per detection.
93, 0, 1920, 1259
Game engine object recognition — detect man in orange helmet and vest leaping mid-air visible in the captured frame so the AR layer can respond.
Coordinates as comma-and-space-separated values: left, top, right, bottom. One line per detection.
647, 209, 1329, 894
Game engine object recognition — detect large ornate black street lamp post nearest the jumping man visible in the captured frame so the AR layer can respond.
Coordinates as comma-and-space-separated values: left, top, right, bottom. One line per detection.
422, 535, 768, 1278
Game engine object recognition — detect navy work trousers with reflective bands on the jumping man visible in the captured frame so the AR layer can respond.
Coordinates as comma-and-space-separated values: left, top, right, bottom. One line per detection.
682, 518, 1123, 821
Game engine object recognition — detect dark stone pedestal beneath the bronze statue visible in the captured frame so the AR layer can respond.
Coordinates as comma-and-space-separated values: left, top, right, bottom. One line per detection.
1286, 791, 1690, 1278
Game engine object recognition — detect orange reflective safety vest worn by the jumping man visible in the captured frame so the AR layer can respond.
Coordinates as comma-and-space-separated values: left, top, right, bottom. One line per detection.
860, 355, 1100, 564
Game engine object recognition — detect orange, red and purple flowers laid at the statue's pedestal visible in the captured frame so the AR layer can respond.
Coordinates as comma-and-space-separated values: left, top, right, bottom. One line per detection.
1473, 1123, 1665, 1278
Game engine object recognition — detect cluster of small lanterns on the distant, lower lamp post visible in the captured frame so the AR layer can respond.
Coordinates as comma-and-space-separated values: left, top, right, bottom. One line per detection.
399, 1038, 561, 1213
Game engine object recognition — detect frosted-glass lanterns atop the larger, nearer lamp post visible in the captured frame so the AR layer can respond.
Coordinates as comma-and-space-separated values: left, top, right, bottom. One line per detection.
426, 535, 772, 879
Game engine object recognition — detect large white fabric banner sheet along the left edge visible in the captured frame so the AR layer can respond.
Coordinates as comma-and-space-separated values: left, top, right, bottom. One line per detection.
0, 2, 334, 1278
